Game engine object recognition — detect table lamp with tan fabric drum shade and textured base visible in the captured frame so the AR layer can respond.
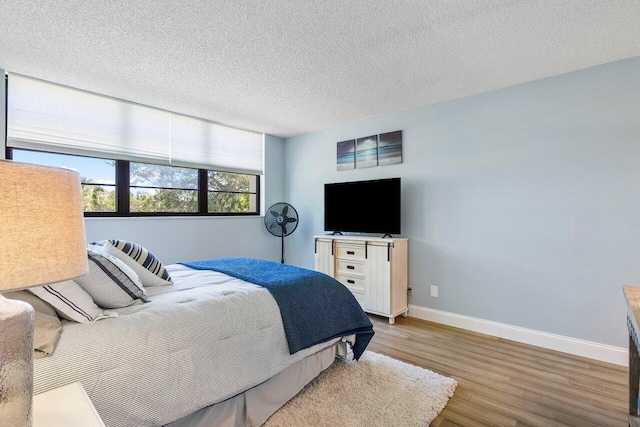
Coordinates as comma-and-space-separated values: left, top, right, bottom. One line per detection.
0, 160, 87, 426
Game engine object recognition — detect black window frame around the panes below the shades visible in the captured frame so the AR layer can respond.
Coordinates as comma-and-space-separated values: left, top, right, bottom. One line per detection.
5, 150, 261, 218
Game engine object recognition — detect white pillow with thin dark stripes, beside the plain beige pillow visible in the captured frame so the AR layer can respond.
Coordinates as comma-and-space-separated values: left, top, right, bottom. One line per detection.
27, 280, 118, 323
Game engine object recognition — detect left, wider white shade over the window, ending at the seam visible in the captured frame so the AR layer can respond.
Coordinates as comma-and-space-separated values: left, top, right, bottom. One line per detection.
7, 74, 171, 165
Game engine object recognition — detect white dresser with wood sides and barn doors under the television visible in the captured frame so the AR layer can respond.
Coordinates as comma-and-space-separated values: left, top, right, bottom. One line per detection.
315, 236, 408, 324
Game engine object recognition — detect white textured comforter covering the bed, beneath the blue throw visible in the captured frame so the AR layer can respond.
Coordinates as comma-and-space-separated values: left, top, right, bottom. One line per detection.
34, 265, 338, 427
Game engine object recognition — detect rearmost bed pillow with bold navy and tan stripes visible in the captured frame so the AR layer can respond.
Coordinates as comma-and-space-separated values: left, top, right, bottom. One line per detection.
94, 240, 173, 286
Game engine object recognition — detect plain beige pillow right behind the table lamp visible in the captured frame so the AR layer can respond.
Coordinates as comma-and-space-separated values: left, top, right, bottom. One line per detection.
2, 291, 62, 359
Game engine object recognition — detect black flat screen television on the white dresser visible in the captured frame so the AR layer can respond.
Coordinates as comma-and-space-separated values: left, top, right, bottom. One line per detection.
324, 178, 401, 235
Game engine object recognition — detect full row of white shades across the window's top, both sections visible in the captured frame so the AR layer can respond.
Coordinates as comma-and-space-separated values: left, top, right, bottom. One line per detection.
7, 74, 263, 175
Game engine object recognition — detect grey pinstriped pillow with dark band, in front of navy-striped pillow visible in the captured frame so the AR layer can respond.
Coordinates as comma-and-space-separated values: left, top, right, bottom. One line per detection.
74, 250, 147, 308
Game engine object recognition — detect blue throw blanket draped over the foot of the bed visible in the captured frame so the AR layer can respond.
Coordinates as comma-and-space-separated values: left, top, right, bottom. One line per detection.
179, 258, 374, 360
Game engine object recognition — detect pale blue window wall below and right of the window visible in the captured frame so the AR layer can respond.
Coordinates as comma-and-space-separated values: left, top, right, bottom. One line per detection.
85, 135, 284, 264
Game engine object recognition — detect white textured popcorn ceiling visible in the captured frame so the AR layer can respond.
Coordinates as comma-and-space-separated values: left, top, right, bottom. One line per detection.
0, 0, 640, 137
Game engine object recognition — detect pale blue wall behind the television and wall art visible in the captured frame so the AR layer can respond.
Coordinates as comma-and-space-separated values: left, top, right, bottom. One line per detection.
285, 58, 640, 347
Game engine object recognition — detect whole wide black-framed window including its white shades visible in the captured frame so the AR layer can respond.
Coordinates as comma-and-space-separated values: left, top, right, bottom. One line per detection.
5, 74, 264, 216
